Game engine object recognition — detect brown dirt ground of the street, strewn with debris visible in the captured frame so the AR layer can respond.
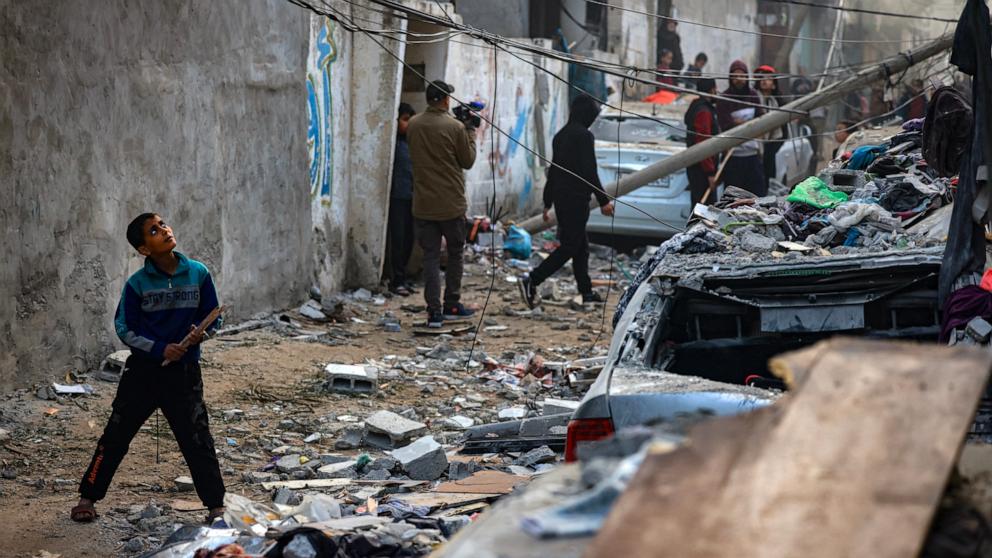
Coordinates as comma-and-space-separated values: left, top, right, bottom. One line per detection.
0, 262, 618, 557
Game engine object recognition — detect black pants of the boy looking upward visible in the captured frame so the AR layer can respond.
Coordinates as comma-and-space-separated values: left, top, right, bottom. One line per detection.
79, 355, 224, 508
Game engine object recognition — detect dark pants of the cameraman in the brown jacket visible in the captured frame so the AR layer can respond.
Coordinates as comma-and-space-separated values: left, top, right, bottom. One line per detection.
414, 217, 468, 312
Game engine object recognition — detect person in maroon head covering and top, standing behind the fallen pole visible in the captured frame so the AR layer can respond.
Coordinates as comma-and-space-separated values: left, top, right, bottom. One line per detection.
716, 60, 768, 196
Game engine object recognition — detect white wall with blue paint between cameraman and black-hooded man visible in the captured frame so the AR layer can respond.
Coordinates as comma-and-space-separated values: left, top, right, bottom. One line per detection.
444, 38, 568, 218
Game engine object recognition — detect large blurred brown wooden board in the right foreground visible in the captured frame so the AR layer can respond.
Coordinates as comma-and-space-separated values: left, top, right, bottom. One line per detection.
586, 339, 992, 558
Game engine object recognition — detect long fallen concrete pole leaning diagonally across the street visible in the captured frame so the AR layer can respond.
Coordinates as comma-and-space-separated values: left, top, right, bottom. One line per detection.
518, 34, 954, 233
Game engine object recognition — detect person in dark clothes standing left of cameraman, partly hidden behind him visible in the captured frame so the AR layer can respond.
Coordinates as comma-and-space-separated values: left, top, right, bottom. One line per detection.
386, 103, 417, 296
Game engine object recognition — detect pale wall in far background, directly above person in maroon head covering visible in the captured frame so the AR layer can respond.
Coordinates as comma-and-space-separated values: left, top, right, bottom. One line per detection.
676, 0, 770, 82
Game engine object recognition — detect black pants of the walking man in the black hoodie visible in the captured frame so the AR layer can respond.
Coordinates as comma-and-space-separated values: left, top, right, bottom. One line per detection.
530, 203, 592, 294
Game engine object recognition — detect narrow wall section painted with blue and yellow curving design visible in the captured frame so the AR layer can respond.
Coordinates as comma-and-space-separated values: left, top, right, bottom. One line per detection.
304, 6, 404, 292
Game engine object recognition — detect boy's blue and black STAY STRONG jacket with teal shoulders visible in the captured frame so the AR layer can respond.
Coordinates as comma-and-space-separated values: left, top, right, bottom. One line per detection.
114, 252, 223, 363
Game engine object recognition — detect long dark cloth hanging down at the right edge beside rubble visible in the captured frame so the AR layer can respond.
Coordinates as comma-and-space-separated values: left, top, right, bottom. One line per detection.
925, 0, 992, 305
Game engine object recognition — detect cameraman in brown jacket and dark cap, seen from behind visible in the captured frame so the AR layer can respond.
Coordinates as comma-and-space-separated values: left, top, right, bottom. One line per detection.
406, 80, 479, 328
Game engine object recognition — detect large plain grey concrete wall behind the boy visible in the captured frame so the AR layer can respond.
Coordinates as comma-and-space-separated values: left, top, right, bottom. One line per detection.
0, 0, 312, 389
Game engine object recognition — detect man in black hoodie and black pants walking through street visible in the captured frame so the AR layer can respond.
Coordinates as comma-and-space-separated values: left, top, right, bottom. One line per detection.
519, 95, 613, 308
